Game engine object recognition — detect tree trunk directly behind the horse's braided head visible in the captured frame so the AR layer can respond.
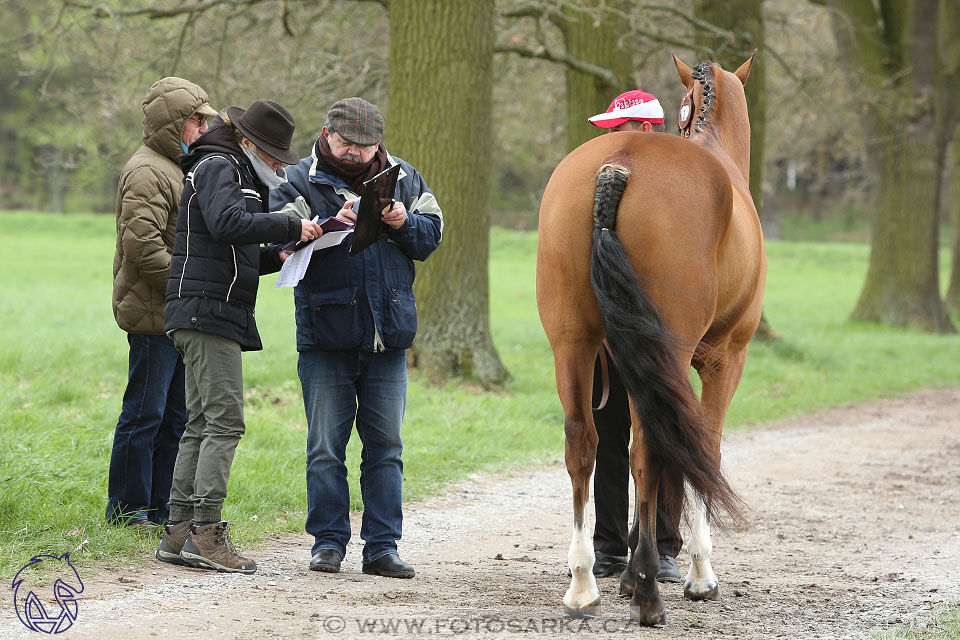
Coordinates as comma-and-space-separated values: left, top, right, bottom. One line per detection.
694, 0, 779, 232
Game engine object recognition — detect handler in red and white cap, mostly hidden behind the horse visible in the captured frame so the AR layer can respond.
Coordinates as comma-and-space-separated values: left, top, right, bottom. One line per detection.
588, 90, 683, 582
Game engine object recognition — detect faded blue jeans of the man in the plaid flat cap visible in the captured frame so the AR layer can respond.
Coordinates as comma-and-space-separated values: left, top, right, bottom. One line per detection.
297, 350, 407, 563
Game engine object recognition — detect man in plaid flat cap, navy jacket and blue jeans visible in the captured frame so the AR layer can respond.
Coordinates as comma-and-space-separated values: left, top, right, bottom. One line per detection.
270, 98, 443, 578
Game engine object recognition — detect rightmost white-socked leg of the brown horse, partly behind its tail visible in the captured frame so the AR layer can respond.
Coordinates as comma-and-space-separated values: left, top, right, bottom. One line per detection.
683, 346, 747, 600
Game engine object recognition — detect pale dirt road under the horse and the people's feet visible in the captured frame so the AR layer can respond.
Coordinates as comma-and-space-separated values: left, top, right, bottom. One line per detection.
0, 389, 960, 640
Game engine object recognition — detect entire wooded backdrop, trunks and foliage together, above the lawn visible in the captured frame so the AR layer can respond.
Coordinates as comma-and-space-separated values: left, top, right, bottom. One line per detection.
0, 0, 960, 376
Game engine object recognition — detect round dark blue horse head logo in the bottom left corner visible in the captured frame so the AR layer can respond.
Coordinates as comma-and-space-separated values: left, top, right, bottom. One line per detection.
10, 553, 83, 634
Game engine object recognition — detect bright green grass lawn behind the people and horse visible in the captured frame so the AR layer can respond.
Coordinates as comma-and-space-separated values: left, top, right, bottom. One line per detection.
0, 213, 960, 578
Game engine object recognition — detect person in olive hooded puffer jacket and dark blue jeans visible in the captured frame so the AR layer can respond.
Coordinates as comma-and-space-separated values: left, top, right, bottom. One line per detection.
107, 77, 217, 526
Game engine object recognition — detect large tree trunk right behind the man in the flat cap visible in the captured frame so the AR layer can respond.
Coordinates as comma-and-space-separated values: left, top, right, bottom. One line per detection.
386, 0, 508, 386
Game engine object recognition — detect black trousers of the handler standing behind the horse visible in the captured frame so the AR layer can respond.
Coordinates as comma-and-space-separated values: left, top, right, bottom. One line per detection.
593, 354, 683, 558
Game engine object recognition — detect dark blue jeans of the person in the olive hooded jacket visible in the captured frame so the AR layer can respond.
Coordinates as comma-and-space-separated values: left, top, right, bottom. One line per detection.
107, 333, 187, 523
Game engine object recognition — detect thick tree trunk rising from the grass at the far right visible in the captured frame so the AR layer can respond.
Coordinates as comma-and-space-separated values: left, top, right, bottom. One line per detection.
833, 0, 955, 333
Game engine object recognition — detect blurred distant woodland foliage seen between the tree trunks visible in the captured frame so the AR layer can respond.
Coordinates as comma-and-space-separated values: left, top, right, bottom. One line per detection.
0, 0, 875, 230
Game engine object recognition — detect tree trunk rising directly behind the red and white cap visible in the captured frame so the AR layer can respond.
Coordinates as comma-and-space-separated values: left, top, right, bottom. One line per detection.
554, 0, 636, 151
